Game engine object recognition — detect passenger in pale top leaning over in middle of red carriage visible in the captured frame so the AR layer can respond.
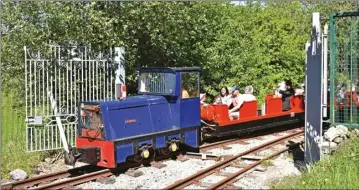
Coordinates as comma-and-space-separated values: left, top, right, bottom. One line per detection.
229, 86, 256, 120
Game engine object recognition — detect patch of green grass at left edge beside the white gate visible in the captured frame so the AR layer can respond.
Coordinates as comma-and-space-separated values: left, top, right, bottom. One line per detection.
1, 94, 44, 179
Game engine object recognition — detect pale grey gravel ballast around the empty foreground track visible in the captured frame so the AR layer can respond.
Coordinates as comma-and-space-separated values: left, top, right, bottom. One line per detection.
78, 131, 297, 189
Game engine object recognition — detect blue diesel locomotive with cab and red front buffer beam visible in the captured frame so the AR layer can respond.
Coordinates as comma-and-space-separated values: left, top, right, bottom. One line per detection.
76, 67, 201, 168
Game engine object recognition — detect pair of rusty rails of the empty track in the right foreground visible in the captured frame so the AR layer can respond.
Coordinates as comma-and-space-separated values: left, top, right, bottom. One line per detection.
165, 130, 304, 189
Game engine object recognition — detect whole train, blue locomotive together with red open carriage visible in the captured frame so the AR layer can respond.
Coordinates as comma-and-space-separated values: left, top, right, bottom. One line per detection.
71, 67, 304, 168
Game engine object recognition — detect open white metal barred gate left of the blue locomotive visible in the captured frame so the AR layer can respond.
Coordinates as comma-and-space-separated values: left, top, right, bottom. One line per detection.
24, 44, 118, 152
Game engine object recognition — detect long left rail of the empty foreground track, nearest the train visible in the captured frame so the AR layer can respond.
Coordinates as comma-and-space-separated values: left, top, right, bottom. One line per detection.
165, 130, 304, 189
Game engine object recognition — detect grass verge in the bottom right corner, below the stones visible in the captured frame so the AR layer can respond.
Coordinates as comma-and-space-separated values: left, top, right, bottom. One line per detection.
272, 137, 359, 189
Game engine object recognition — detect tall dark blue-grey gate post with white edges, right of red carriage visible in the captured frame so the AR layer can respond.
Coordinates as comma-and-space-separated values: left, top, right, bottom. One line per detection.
304, 13, 327, 164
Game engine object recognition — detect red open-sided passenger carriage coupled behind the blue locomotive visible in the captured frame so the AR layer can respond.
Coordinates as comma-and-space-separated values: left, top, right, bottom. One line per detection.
201, 94, 304, 139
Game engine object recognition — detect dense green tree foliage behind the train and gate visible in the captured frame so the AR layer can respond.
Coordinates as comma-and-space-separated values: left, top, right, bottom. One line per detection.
1, 1, 356, 178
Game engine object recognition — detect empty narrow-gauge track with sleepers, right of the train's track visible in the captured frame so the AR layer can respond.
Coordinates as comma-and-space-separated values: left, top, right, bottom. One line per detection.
165, 130, 304, 189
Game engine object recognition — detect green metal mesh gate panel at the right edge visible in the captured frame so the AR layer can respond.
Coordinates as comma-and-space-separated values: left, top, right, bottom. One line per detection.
329, 12, 359, 128
